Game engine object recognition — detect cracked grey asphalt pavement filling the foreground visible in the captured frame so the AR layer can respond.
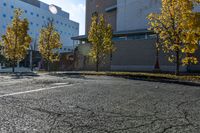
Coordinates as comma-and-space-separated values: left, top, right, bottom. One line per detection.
0, 74, 200, 133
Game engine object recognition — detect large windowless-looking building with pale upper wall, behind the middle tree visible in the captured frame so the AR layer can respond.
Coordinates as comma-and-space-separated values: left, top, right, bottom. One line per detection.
73, 0, 200, 71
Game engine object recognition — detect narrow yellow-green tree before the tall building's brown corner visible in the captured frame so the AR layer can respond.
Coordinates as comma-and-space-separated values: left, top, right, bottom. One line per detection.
88, 14, 114, 72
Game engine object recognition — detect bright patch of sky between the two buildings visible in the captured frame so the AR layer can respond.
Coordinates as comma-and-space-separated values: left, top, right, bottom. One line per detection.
40, 0, 85, 35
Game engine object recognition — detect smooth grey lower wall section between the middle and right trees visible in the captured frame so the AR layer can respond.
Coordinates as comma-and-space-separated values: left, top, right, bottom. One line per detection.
111, 39, 186, 71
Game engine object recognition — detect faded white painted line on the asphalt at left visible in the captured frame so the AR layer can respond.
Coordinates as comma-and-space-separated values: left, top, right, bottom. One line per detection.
0, 84, 73, 98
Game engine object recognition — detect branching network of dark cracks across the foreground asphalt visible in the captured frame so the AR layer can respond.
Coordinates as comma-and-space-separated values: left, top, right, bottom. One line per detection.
0, 93, 200, 133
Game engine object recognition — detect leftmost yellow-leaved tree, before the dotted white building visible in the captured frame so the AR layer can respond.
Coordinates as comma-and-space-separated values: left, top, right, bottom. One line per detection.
1, 9, 31, 72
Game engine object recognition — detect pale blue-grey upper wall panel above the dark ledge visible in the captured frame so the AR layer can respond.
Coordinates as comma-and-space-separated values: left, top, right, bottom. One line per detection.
117, 0, 161, 31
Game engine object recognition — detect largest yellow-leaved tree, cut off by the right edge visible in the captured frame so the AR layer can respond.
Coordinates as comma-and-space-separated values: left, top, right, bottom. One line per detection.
148, 0, 200, 75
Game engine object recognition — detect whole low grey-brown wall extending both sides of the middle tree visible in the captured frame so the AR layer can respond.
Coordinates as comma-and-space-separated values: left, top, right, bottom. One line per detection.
75, 39, 189, 72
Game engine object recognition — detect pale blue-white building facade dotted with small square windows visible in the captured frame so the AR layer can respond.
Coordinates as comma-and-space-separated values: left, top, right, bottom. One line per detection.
0, 0, 79, 53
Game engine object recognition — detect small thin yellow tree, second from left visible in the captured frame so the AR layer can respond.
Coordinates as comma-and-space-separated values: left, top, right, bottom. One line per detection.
39, 20, 62, 71
